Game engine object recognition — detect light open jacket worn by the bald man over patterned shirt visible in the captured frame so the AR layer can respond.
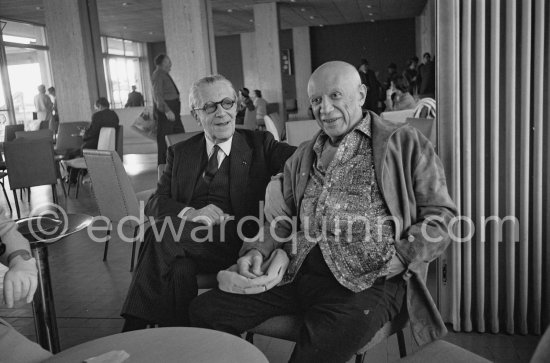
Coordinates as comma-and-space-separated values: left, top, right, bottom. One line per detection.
241, 112, 457, 345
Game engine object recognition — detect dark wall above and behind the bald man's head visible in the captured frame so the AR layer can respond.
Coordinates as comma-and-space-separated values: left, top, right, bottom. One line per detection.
310, 18, 416, 79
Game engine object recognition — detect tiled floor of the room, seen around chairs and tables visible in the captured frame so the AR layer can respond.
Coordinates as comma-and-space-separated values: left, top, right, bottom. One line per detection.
0, 155, 539, 363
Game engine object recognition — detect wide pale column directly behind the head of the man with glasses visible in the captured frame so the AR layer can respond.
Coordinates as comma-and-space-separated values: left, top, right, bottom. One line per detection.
162, 0, 217, 115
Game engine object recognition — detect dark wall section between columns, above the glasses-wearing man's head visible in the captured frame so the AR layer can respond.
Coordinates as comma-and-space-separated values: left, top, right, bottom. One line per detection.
215, 34, 244, 89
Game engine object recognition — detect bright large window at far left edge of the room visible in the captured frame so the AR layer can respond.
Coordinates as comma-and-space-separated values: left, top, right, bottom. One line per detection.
0, 20, 53, 136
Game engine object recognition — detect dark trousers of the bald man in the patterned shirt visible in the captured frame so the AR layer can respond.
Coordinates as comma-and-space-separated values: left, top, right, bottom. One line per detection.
190, 246, 405, 363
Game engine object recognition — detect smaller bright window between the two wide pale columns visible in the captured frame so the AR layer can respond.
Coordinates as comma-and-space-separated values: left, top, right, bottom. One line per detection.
101, 37, 145, 108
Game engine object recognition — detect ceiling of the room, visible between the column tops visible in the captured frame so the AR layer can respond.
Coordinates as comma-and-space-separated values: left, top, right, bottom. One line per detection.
0, 0, 426, 42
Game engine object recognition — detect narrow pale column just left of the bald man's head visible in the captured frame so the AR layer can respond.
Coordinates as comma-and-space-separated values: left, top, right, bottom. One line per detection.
292, 26, 311, 119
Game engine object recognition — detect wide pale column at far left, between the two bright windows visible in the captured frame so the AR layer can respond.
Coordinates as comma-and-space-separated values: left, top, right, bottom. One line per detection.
44, 0, 107, 122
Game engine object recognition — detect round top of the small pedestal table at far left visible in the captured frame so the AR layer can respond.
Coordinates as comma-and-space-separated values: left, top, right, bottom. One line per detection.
15, 213, 93, 246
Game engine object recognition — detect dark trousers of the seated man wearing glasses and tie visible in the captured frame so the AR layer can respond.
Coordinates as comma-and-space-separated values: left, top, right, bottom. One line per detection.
122, 217, 240, 330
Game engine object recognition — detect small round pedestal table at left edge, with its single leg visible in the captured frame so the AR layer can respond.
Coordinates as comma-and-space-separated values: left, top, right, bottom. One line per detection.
15, 213, 93, 353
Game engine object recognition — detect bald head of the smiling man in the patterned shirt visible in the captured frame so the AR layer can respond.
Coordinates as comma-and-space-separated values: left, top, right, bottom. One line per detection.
307, 61, 367, 142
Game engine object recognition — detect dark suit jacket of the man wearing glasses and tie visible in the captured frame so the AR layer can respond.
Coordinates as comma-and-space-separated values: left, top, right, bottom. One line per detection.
145, 130, 296, 229
